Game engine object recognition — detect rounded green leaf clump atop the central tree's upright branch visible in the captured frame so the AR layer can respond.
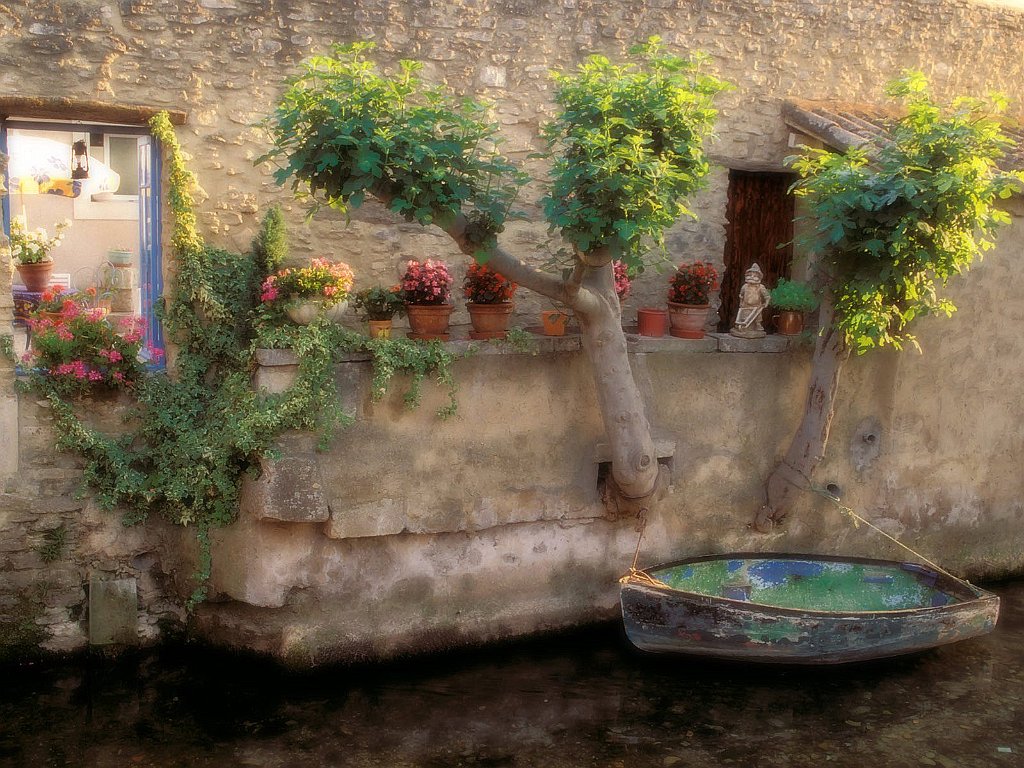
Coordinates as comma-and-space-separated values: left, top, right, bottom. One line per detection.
544, 38, 728, 270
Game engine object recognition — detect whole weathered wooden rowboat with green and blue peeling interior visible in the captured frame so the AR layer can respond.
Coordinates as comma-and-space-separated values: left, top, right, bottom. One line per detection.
620, 553, 999, 665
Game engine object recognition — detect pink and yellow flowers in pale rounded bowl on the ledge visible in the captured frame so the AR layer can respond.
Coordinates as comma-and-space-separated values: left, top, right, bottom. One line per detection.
260, 259, 354, 326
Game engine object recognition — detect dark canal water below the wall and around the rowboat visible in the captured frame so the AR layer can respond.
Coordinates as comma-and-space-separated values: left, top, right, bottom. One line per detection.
0, 583, 1024, 768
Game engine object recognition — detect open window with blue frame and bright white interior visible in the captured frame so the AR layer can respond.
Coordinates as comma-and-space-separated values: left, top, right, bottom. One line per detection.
0, 119, 163, 364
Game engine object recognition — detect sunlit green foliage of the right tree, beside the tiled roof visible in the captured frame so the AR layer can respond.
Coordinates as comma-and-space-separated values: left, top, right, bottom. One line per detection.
792, 73, 1022, 352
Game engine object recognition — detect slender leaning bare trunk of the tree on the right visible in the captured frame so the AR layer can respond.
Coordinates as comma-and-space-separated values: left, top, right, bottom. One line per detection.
754, 292, 850, 534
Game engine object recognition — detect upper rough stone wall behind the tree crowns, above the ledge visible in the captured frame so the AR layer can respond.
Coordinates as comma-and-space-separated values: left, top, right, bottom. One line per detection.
0, 0, 1024, 318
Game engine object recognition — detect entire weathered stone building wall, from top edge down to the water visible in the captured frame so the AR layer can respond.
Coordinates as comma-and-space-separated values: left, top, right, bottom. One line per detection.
0, 0, 1024, 660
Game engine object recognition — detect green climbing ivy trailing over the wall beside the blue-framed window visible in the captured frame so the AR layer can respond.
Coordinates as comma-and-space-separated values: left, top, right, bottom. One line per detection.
32, 114, 464, 607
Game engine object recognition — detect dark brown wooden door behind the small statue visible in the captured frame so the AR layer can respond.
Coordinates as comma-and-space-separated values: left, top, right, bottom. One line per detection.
719, 170, 796, 331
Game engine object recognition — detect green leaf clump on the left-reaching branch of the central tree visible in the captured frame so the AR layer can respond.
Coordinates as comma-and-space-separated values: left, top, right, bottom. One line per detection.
258, 43, 526, 252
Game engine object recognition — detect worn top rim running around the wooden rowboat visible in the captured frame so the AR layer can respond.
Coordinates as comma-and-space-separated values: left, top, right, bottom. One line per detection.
622, 552, 999, 618
